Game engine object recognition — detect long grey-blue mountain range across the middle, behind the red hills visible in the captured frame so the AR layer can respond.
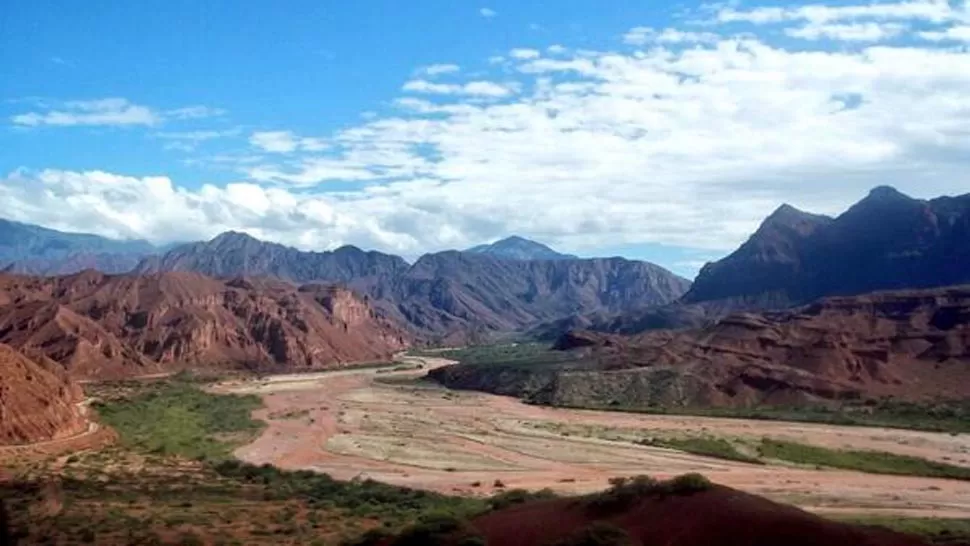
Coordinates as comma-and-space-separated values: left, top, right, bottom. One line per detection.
142, 232, 690, 342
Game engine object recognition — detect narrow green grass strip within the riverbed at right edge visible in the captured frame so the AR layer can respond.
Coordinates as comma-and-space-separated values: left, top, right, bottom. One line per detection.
758, 438, 970, 480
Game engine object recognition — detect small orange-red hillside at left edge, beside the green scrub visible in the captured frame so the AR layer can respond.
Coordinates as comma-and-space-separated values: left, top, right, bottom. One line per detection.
0, 344, 87, 444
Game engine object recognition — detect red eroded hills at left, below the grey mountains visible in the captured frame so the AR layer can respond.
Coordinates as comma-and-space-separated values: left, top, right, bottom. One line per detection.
0, 271, 407, 379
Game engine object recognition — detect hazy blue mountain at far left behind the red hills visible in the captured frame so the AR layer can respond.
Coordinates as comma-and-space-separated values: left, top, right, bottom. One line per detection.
0, 219, 159, 275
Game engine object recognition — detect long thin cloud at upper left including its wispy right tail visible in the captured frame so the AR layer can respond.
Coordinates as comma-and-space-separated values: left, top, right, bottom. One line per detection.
10, 98, 225, 127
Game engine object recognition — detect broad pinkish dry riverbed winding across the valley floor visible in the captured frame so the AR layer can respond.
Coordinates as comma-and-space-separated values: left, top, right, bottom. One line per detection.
218, 357, 970, 517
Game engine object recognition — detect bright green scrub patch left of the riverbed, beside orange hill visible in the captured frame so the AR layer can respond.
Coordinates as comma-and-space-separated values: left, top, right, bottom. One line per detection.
95, 381, 263, 460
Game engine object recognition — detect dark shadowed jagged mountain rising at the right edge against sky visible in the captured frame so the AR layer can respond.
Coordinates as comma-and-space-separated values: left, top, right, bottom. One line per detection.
683, 186, 970, 308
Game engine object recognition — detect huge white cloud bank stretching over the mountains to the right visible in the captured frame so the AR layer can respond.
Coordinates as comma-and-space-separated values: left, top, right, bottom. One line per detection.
0, 1, 970, 268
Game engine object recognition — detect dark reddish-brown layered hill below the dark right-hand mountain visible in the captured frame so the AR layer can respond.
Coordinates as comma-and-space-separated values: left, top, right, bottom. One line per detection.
433, 286, 970, 407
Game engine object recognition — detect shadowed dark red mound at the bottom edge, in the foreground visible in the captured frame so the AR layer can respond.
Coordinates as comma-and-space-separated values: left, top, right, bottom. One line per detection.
372, 475, 928, 546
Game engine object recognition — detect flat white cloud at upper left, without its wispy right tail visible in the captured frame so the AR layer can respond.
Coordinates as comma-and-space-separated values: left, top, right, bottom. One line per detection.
11, 98, 162, 127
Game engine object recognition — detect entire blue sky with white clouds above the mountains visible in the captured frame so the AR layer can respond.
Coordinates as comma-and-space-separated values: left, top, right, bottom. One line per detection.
0, 0, 970, 276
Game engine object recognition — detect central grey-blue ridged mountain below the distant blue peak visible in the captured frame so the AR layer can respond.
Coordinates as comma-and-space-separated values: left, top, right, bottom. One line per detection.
382, 251, 690, 340
